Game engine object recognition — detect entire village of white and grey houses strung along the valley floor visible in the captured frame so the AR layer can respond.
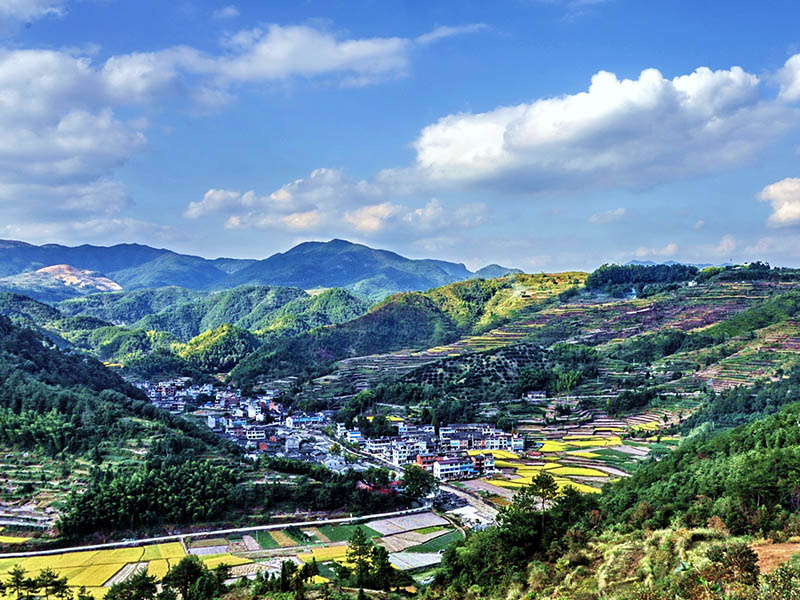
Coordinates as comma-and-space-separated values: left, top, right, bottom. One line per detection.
139, 378, 525, 481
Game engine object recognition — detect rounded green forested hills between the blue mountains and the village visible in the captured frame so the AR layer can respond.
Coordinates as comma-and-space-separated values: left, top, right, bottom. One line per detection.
0, 286, 368, 377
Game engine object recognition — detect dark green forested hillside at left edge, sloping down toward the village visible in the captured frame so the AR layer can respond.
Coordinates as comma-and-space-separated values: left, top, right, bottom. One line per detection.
0, 316, 228, 455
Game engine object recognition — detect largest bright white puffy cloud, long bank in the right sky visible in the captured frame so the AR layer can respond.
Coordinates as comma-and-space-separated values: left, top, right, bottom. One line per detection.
379, 62, 798, 192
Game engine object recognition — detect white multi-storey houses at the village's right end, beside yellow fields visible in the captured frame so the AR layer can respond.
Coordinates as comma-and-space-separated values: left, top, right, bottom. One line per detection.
337, 422, 525, 480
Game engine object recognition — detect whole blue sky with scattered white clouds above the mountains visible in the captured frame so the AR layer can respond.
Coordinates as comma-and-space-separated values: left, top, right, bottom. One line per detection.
0, 0, 800, 272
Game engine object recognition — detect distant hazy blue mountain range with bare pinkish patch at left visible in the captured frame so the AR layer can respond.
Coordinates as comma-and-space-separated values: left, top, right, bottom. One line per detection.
0, 239, 521, 302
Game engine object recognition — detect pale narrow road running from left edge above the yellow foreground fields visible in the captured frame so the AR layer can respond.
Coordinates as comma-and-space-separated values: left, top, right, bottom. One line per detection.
0, 507, 430, 558
